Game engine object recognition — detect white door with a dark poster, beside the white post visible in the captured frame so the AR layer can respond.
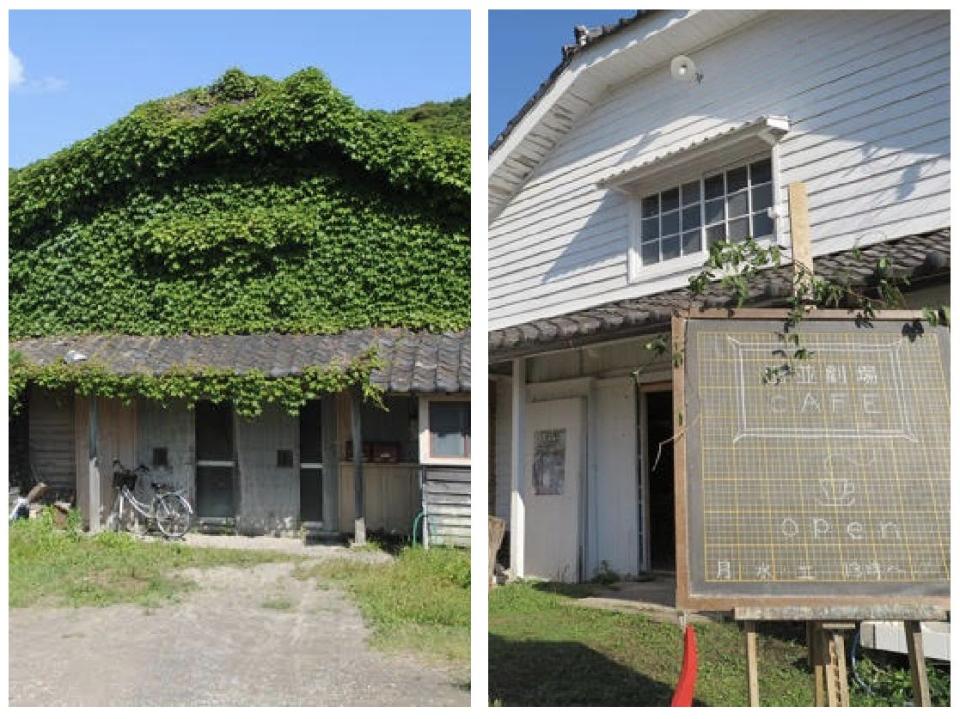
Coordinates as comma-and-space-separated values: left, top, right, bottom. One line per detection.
523, 399, 585, 582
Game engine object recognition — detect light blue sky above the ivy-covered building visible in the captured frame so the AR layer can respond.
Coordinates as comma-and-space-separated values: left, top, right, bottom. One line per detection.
10, 10, 470, 167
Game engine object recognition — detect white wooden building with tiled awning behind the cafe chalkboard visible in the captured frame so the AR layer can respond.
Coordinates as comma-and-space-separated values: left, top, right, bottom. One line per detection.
488, 10, 950, 581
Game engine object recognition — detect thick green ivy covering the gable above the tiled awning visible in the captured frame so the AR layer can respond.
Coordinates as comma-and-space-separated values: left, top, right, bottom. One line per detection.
10, 69, 470, 338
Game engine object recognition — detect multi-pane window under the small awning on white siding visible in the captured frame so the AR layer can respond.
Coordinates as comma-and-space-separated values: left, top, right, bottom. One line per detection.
640, 155, 774, 267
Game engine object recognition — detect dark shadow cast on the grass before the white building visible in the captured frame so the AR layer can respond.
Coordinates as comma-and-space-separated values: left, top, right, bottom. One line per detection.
489, 634, 688, 707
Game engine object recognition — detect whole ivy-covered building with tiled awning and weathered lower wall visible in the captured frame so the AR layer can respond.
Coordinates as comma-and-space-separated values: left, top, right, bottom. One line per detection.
10, 70, 470, 543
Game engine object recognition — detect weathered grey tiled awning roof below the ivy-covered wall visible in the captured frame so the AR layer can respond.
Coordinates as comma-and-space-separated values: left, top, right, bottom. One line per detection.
10, 329, 470, 392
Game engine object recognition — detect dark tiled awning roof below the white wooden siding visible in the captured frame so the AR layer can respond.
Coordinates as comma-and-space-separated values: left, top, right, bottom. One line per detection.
496, 228, 950, 362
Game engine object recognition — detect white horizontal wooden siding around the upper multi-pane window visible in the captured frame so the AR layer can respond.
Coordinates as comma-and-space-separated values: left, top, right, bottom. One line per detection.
489, 11, 950, 328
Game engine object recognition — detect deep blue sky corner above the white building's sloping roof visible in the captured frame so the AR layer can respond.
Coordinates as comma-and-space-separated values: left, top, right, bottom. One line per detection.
487, 9, 635, 142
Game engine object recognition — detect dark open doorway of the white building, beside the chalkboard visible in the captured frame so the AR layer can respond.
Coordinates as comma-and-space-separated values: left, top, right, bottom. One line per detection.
646, 391, 676, 571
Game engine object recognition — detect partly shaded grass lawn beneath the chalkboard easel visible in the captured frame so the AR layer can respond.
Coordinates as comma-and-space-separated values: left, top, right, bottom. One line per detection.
489, 583, 949, 706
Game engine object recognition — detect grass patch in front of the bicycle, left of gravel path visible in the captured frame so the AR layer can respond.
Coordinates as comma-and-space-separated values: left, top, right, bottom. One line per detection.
9, 513, 288, 607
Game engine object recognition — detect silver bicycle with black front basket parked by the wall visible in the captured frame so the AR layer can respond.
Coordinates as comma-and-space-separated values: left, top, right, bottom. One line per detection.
110, 459, 193, 539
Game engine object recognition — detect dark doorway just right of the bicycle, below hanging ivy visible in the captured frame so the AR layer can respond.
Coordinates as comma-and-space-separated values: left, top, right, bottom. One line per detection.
194, 402, 236, 518
